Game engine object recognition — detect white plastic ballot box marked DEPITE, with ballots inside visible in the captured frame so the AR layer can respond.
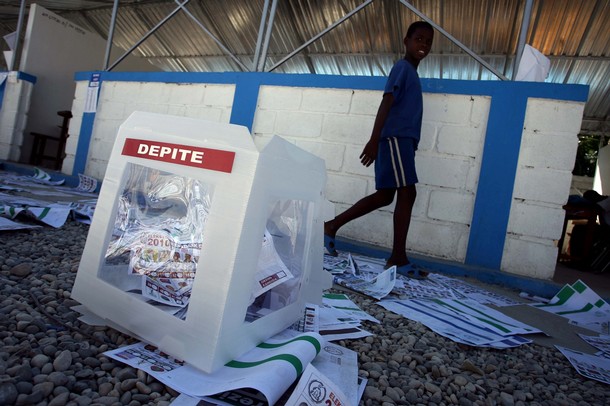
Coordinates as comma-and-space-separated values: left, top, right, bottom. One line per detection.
72, 112, 331, 372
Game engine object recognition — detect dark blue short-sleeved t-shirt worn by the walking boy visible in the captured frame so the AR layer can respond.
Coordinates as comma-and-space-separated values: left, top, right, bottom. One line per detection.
381, 59, 424, 145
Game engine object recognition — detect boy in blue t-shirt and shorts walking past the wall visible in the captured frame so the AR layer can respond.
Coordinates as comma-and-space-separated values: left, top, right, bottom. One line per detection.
324, 21, 434, 278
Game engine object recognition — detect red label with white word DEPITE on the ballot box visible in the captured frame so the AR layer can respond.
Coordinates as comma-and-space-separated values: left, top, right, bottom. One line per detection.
122, 138, 235, 173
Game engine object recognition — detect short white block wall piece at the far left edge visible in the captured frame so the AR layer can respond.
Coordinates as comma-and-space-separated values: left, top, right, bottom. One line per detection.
0, 71, 36, 162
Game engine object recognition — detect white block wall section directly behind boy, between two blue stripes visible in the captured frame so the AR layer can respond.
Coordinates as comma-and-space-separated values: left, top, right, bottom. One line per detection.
252, 86, 489, 262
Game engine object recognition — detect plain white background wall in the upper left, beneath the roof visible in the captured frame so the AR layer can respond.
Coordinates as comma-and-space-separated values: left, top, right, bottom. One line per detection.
19, 4, 158, 162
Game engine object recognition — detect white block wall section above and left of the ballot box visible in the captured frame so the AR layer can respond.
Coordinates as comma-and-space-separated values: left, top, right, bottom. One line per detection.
62, 81, 235, 179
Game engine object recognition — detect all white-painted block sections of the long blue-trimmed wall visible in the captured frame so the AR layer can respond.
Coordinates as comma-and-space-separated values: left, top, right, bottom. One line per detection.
63, 80, 584, 279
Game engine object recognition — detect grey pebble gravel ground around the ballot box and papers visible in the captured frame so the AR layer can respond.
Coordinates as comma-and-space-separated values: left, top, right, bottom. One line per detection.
0, 221, 610, 406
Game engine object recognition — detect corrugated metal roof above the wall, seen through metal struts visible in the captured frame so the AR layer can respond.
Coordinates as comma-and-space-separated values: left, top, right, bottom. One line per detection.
0, 0, 610, 134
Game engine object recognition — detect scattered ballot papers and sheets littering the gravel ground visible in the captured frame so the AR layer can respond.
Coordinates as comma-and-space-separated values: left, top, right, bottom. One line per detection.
0, 170, 610, 406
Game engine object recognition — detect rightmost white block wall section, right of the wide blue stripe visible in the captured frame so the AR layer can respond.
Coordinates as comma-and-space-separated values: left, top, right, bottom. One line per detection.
502, 99, 584, 279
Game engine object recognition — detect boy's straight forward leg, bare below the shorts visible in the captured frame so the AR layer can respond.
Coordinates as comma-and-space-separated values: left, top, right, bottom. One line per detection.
386, 185, 417, 266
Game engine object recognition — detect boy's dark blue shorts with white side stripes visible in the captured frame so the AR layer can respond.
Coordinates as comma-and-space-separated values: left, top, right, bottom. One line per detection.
375, 137, 417, 190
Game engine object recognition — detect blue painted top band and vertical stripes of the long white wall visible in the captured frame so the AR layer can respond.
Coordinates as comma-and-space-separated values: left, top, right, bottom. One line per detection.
73, 72, 589, 269
